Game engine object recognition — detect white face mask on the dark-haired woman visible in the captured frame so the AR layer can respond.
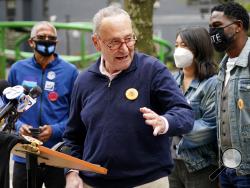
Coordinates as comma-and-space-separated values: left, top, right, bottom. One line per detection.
174, 47, 194, 68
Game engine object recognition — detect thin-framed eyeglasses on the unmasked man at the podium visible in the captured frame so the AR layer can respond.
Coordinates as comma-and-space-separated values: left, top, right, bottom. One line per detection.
98, 35, 137, 50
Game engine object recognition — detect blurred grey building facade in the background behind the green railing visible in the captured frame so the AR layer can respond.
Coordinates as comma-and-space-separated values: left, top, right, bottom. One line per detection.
0, 0, 217, 58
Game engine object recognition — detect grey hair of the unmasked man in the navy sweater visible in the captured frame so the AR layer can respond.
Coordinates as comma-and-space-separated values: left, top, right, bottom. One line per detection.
93, 5, 131, 34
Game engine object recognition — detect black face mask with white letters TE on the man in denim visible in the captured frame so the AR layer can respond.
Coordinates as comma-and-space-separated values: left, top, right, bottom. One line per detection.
209, 22, 234, 52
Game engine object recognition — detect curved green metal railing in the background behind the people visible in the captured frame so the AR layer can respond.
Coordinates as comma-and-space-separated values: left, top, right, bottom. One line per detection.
0, 21, 173, 79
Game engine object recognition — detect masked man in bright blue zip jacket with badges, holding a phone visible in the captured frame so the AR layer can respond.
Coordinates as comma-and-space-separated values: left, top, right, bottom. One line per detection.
8, 21, 78, 188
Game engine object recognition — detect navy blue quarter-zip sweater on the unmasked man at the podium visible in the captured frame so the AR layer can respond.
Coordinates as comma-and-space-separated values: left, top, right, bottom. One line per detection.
64, 53, 194, 188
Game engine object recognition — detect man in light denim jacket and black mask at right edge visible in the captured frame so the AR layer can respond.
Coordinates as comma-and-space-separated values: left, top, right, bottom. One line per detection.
209, 2, 250, 188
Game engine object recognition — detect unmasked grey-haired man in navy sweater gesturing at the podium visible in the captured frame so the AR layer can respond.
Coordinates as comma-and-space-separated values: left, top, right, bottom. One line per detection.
63, 6, 194, 188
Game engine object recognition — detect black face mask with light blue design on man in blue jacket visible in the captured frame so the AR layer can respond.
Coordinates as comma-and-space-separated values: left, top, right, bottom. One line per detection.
35, 40, 56, 57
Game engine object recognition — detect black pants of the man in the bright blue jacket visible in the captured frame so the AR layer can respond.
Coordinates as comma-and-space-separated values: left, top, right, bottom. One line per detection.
13, 162, 65, 188
